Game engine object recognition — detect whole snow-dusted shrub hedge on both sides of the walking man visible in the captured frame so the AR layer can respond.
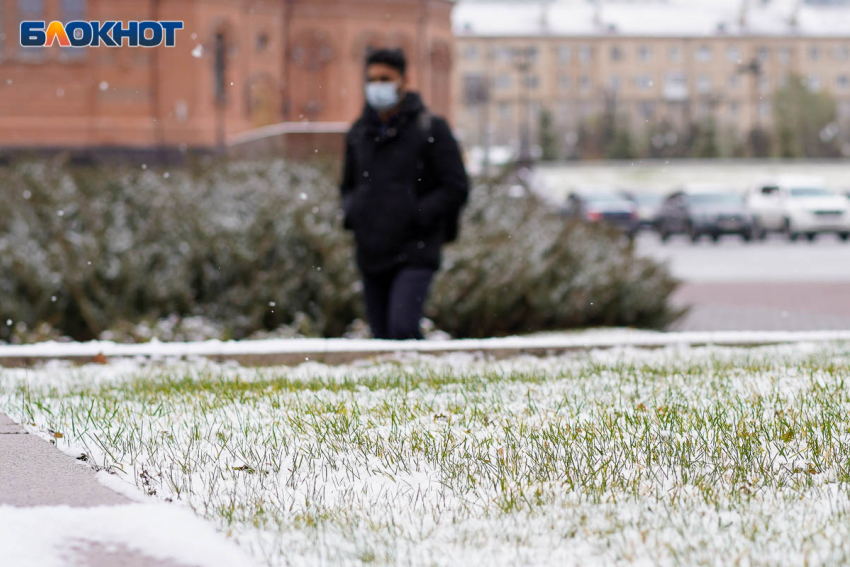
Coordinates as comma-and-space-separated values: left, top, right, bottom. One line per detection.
0, 161, 673, 340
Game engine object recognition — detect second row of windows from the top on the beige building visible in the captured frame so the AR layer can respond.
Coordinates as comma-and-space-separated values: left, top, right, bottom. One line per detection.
484, 72, 850, 93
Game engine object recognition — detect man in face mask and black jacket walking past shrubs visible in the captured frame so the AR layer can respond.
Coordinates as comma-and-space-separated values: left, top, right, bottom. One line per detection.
341, 49, 469, 340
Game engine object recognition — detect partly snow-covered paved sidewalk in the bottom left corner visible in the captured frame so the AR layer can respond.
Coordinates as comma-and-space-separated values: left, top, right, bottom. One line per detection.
0, 414, 251, 567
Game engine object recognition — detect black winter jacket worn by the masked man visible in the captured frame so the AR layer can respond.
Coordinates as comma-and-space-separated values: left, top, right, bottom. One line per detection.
341, 93, 469, 273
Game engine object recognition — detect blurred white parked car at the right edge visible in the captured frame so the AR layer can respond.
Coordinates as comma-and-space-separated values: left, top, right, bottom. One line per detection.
747, 177, 850, 241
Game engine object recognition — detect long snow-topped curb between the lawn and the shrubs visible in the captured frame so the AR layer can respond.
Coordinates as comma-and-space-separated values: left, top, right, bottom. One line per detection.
0, 331, 850, 368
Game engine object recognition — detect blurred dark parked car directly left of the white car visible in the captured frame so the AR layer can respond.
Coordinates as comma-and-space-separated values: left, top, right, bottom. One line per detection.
657, 187, 754, 242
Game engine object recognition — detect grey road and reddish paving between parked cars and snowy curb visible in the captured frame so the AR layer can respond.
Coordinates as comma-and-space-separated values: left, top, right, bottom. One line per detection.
637, 234, 850, 331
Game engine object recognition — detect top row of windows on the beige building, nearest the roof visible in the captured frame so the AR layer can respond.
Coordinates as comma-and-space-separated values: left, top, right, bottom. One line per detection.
461, 44, 850, 64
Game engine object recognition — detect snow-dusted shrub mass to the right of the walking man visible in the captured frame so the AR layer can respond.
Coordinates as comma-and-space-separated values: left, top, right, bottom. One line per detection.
430, 185, 678, 337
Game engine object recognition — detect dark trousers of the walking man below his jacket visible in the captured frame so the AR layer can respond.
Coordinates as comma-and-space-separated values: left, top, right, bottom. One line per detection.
363, 267, 434, 340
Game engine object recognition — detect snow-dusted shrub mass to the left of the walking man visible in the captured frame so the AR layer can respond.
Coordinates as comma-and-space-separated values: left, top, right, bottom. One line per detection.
0, 161, 361, 339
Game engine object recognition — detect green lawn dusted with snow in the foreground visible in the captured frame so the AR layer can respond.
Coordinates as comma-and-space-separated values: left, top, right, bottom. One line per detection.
0, 343, 850, 567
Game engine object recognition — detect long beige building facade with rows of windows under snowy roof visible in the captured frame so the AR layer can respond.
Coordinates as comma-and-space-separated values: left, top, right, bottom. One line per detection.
455, 2, 850, 155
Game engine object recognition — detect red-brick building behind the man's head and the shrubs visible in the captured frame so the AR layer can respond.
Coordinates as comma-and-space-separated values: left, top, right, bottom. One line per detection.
0, 0, 453, 155
